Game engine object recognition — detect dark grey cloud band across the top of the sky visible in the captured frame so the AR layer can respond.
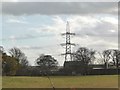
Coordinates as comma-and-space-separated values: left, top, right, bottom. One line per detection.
2, 2, 118, 15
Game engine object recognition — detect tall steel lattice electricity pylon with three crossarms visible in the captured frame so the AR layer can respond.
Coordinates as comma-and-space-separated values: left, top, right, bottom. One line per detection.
61, 21, 75, 61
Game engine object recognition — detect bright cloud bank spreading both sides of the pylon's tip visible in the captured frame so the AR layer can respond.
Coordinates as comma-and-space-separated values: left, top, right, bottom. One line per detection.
32, 15, 118, 37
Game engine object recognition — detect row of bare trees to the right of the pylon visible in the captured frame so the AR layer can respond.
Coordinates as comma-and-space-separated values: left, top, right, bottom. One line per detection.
73, 47, 120, 69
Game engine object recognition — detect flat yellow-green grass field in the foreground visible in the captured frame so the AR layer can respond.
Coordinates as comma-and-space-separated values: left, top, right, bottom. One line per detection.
2, 75, 118, 88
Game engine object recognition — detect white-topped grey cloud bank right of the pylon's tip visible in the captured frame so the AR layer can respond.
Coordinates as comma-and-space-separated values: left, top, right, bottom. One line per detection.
69, 16, 118, 37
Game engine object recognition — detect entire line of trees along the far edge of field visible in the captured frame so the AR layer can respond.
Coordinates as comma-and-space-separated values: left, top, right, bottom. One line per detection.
0, 47, 120, 75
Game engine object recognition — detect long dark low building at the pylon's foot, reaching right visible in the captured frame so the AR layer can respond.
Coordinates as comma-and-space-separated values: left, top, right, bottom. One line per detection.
64, 61, 119, 75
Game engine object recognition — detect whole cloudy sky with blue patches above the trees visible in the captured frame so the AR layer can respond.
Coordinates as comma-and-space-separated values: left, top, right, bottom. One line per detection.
0, 0, 118, 65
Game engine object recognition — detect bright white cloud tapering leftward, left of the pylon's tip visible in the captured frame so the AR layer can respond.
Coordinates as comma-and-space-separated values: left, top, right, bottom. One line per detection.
30, 16, 66, 36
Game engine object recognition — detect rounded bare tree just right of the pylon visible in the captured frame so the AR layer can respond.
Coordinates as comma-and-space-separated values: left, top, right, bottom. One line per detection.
74, 47, 95, 74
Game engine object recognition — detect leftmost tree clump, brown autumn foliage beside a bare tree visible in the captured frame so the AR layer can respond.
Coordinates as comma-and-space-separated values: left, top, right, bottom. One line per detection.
0, 48, 29, 75
